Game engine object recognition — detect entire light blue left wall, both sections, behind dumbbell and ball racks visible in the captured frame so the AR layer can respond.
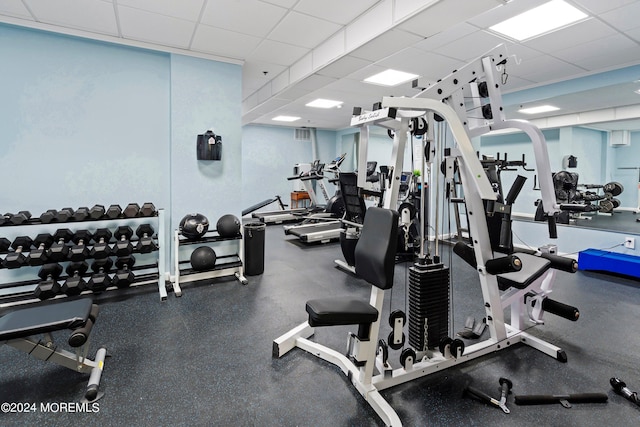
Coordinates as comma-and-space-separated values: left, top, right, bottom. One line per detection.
0, 24, 242, 278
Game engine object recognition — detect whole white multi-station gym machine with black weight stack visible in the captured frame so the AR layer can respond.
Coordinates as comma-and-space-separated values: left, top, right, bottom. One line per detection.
273, 45, 579, 426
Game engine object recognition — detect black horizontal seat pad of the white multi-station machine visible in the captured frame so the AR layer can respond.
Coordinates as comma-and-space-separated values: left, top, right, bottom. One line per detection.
306, 298, 378, 326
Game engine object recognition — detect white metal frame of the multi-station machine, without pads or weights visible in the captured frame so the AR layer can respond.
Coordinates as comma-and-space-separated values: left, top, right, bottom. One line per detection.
273, 46, 566, 426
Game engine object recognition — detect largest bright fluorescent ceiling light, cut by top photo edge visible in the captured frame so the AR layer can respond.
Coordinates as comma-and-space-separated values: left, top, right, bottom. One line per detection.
489, 0, 589, 41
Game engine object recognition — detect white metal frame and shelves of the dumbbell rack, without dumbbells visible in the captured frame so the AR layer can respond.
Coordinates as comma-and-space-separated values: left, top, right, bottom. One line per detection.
0, 209, 167, 307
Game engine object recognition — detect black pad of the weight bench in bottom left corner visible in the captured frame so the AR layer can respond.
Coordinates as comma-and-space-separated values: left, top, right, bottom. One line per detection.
0, 298, 93, 341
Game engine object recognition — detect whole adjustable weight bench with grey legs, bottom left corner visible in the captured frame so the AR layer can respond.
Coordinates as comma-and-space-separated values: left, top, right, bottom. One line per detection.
0, 298, 107, 401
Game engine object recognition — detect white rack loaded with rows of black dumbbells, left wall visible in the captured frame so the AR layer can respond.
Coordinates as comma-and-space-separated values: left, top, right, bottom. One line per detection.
0, 209, 167, 307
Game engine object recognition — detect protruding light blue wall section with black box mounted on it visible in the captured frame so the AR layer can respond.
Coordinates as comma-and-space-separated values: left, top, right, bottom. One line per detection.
171, 55, 242, 229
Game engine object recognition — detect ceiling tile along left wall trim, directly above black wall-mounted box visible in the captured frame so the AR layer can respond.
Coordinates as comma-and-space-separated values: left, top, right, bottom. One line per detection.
191, 24, 260, 59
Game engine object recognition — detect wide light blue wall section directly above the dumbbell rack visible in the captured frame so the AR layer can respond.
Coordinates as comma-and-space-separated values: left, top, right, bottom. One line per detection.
0, 25, 170, 215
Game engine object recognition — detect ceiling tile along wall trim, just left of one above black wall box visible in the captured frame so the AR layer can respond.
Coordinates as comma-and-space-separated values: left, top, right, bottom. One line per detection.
118, 6, 196, 49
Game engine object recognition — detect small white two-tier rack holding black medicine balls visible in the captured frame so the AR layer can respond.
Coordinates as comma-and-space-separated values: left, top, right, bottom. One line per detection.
170, 230, 247, 297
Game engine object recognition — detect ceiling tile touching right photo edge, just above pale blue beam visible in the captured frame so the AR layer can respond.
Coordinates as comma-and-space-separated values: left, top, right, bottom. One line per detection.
554, 35, 640, 70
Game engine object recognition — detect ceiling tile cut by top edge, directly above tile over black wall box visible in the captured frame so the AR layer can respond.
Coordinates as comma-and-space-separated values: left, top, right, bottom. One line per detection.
201, 0, 287, 37
